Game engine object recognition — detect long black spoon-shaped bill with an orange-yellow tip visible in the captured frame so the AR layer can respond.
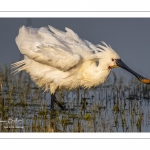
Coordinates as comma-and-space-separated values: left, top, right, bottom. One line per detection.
116, 59, 150, 84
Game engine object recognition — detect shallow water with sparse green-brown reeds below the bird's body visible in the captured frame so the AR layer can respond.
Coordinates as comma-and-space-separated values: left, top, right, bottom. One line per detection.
0, 67, 150, 132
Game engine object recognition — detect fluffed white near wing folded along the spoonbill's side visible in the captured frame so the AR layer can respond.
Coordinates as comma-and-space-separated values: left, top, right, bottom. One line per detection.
16, 26, 83, 71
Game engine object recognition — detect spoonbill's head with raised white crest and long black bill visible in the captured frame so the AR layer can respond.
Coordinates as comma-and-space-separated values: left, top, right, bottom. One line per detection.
97, 42, 150, 84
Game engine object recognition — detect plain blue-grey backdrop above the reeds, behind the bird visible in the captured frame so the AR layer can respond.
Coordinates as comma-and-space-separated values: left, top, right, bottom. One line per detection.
0, 18, 150, 81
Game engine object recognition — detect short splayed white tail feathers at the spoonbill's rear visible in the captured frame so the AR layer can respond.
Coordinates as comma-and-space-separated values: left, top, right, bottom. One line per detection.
11, 60, 28, 75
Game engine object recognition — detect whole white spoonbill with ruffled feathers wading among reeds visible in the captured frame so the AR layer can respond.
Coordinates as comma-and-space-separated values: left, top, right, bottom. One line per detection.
12, 26, 150, 109
